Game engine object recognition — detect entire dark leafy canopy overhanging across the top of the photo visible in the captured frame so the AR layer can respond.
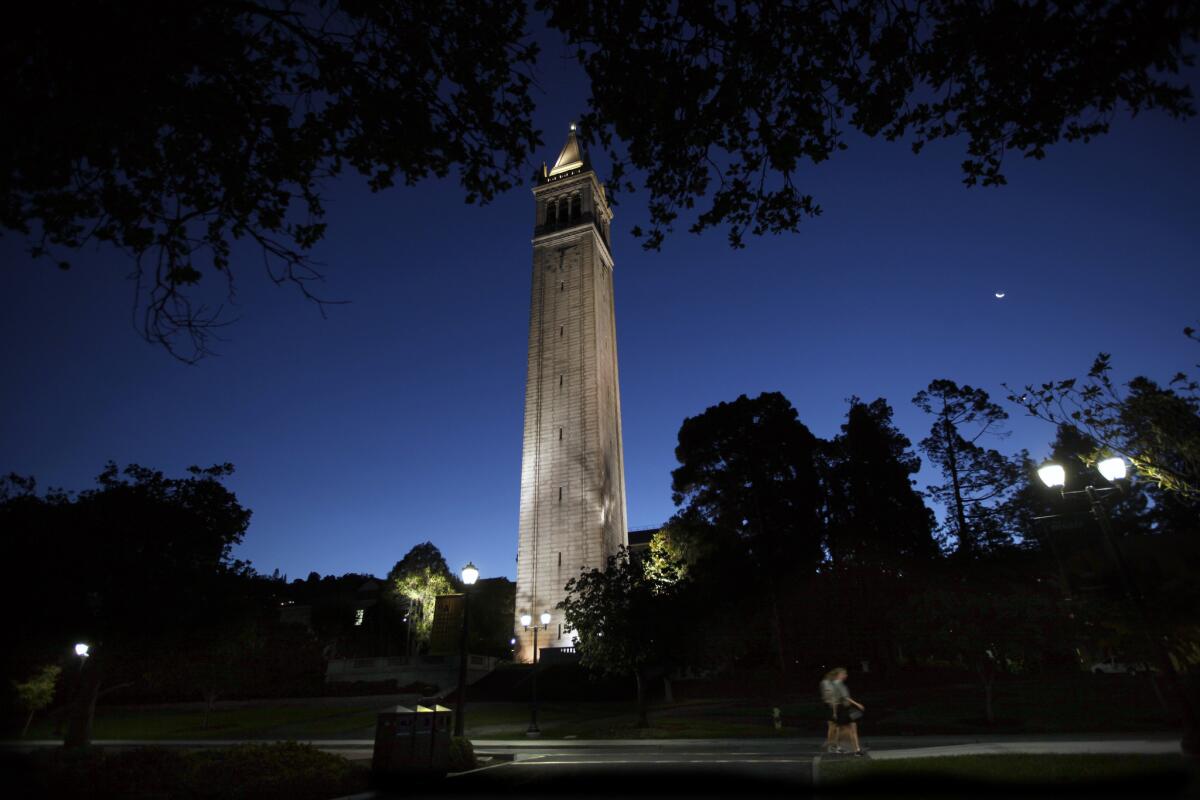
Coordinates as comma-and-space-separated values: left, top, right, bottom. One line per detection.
0, 0, 1200, 361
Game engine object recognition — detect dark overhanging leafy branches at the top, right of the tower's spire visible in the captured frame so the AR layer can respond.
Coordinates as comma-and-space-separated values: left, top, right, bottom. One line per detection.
547, 0, 1200, 248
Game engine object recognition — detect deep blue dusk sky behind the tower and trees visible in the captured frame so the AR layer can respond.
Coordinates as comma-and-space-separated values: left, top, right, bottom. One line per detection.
0, 34, 1200, 585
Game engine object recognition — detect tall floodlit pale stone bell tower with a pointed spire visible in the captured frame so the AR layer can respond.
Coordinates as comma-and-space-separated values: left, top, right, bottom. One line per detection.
514, 125, 628, 662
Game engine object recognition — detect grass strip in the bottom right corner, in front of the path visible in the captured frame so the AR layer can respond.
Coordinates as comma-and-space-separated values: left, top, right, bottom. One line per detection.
820, 754, 1196, 796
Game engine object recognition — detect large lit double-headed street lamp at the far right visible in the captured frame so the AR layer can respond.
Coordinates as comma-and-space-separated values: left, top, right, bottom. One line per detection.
1038, 457, 1200, 757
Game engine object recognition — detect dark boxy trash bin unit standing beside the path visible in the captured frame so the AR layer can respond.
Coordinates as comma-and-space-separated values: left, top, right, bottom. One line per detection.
371, 705, 451, 784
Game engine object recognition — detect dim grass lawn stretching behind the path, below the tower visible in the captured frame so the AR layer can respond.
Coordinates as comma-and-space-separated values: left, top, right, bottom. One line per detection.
10, 674, 1174, 740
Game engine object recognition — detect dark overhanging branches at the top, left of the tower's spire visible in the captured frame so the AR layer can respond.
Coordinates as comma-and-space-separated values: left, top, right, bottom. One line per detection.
0, 0, 540, 361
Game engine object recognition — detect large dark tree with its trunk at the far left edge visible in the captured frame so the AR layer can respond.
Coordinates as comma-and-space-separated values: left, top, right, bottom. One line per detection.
0, 463, 250, 746
